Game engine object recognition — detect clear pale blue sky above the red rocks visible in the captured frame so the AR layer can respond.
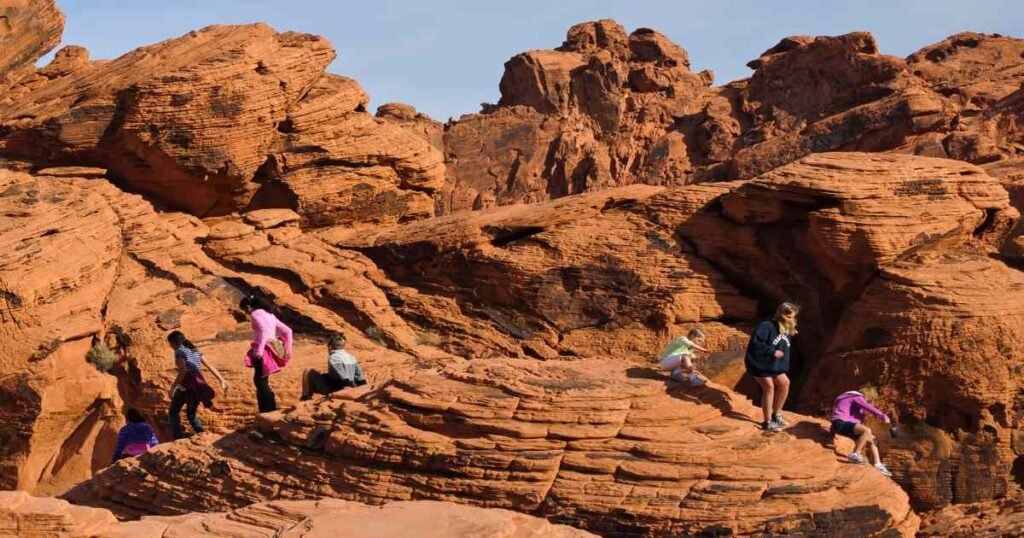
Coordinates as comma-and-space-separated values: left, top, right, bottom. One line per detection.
45, 0, 1024, 121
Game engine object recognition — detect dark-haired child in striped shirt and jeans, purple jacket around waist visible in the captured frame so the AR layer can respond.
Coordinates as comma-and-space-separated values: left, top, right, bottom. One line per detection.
167, 331, 227, 440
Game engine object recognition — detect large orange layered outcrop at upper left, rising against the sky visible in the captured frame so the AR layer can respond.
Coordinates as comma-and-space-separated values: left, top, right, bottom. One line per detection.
0, 17, 443, 225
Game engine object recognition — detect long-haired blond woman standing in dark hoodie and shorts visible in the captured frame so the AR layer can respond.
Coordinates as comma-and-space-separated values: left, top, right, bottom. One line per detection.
743, 302, 800, 431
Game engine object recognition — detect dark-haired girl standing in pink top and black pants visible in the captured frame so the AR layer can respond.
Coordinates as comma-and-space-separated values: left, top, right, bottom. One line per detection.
239, 295, 292, 413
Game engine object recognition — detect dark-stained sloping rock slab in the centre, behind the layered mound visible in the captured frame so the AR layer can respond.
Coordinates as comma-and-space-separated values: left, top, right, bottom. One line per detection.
319, 185, 756, 362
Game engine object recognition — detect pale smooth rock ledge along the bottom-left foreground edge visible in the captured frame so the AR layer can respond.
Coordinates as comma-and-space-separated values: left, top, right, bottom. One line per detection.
0, 492, 593, 538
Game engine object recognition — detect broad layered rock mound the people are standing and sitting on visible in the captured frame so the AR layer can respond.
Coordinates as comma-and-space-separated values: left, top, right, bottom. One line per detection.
61, 359, 918, 536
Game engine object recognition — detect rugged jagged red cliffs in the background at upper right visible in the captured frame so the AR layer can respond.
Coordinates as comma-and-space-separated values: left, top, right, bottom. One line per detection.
439, 20, 1024, 211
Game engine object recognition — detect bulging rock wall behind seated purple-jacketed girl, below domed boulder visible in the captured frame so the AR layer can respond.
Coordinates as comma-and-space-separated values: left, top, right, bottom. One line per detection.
803, 249, 1024, 508
